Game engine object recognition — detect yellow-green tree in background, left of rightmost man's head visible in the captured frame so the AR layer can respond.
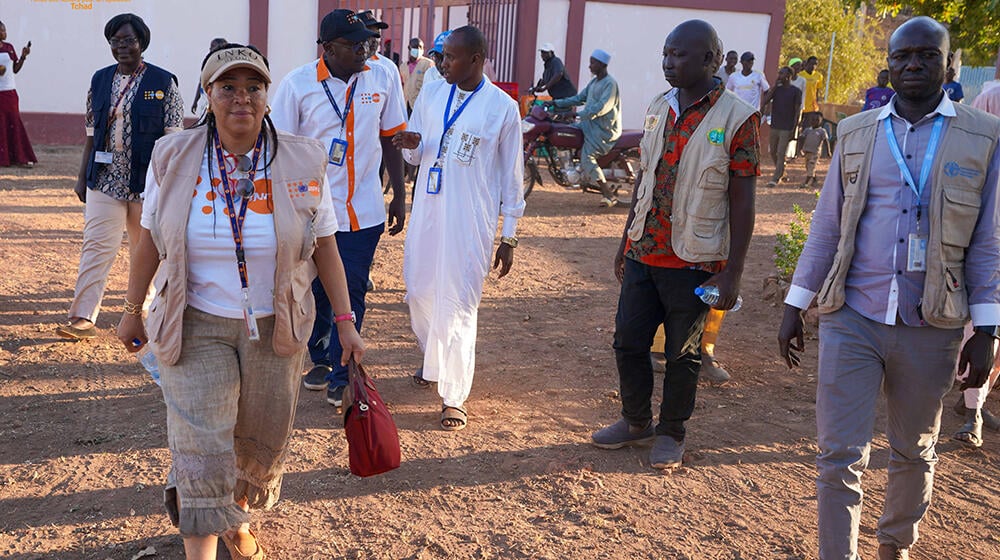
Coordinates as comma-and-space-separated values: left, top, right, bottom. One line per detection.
780, 0, 885, 104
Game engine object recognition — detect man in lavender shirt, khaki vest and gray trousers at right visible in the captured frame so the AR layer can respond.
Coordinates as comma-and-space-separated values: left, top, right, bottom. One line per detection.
778, 17, 1000, 560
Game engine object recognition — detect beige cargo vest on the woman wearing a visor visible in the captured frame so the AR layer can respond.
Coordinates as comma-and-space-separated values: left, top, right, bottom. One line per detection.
146, 127, 326, 365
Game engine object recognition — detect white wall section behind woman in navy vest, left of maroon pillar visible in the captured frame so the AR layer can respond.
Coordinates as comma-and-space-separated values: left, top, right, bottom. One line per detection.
0, 0, 250, 117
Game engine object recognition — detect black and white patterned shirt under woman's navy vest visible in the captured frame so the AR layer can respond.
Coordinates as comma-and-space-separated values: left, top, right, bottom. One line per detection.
86, 64, 184, 202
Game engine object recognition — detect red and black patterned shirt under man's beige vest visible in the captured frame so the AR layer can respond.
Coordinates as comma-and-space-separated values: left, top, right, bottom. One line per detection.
625, 85, 760, 274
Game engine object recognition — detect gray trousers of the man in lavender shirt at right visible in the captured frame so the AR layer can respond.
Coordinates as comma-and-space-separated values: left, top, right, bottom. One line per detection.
816, 305, 962, 560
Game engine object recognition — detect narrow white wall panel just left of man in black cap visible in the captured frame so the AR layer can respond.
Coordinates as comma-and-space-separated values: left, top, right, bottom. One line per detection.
267, 0, 319, 86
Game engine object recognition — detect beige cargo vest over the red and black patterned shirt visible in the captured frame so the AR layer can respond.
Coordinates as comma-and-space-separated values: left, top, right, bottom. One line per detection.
628, 90, 756, 263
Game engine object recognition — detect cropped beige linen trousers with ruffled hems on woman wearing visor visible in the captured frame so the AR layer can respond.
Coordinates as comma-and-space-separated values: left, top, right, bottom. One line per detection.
160, 307, 305, 537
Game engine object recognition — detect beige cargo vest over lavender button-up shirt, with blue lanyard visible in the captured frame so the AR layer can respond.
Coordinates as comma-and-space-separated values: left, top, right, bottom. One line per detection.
816, 103, 1000, 329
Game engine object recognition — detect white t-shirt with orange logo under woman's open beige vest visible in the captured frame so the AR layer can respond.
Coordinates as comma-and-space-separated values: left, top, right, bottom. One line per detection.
141, 152, 337, 319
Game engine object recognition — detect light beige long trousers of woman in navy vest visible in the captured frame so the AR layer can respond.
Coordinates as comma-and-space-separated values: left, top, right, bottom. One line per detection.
69, 190, 142, 322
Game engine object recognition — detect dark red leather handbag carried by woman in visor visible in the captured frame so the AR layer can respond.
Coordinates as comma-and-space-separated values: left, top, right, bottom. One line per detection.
344, 358, 400, 476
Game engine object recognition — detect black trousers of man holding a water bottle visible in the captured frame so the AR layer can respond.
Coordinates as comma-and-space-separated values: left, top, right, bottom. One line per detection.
614, 259, 711, 440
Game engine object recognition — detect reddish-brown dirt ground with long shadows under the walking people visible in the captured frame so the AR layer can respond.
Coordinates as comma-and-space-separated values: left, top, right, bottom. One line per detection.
0, 146, 1000, 560
